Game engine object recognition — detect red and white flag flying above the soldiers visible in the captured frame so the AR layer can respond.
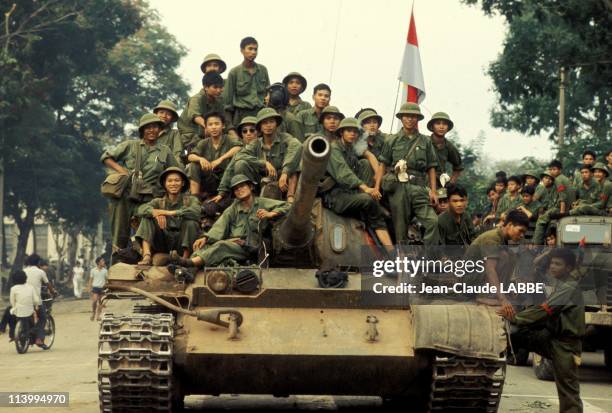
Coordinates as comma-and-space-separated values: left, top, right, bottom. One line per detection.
398, 6, 425, 103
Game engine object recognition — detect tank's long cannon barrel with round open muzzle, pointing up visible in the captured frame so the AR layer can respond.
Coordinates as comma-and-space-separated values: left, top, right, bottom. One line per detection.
278, 135, 331, 248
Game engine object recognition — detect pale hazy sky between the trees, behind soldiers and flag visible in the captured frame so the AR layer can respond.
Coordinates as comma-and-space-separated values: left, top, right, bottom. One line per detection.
150, 0, 552, 160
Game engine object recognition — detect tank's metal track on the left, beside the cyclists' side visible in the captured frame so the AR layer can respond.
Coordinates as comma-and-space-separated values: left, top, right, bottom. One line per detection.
98, 313, 175, 413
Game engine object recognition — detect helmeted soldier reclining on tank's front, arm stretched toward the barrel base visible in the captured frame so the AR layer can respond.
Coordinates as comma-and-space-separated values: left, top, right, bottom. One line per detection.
171, 175, 290, 267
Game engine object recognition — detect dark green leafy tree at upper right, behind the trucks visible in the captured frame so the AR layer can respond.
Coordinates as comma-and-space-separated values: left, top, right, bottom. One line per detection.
462, 0, 612, 148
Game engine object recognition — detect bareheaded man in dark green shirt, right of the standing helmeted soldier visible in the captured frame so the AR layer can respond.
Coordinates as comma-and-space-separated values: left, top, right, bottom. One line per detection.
438, 184, 476, 247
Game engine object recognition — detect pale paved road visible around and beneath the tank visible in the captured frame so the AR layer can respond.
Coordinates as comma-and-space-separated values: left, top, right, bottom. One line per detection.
0, 300, 612, 413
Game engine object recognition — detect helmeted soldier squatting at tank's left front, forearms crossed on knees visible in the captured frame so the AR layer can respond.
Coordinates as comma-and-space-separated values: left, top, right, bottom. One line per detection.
135, 167, 200, 265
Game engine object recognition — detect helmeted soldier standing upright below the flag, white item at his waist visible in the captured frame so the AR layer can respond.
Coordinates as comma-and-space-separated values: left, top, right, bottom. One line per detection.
380, 103, 439, 245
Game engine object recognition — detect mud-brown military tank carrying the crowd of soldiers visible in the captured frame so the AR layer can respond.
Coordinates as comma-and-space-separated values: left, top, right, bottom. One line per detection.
98, 136, 506, 412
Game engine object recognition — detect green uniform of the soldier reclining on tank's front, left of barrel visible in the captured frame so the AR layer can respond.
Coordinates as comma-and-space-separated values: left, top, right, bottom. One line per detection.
192, 192, 291, 267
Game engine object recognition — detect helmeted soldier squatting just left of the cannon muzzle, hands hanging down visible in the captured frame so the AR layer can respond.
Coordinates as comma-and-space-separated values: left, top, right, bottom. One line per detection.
234, 108, 302, 202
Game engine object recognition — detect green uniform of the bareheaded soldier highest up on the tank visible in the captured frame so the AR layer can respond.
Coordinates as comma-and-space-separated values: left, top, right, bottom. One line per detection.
223, 63, 270, 125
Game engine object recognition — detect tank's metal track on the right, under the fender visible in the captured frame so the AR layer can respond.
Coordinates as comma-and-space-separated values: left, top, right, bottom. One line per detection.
429, 355, 506, 413
